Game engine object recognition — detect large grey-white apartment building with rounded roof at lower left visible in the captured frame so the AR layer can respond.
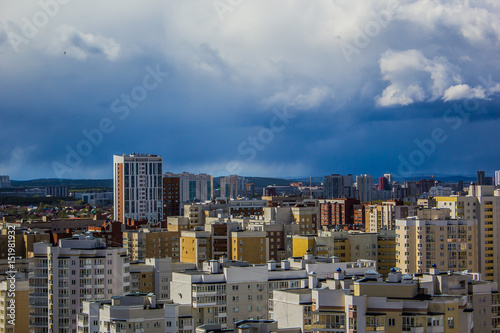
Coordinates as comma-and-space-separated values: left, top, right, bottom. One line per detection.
29, 236, 130, 333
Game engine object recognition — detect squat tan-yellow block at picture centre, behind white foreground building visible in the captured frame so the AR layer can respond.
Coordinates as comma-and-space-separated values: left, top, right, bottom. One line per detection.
231, 230, 269, 264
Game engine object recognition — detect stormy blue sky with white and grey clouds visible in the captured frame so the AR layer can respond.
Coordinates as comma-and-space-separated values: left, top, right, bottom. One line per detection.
0, 0, 500, 180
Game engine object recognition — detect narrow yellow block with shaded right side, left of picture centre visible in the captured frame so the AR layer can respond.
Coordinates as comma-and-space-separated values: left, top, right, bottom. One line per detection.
181, 230, 212, 268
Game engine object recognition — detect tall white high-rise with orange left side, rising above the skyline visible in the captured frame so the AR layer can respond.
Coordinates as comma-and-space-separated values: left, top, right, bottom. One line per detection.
113, 153, 163, 223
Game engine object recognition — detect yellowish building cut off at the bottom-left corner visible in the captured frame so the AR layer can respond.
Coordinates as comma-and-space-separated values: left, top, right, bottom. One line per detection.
0, 274, 29, 333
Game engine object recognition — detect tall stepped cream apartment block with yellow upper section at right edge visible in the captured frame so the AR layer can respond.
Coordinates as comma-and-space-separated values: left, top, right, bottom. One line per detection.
436, 185, 500, 282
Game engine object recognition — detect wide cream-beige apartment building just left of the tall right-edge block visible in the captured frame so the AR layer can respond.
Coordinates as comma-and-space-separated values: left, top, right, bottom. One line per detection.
396, 217, 479, 273
